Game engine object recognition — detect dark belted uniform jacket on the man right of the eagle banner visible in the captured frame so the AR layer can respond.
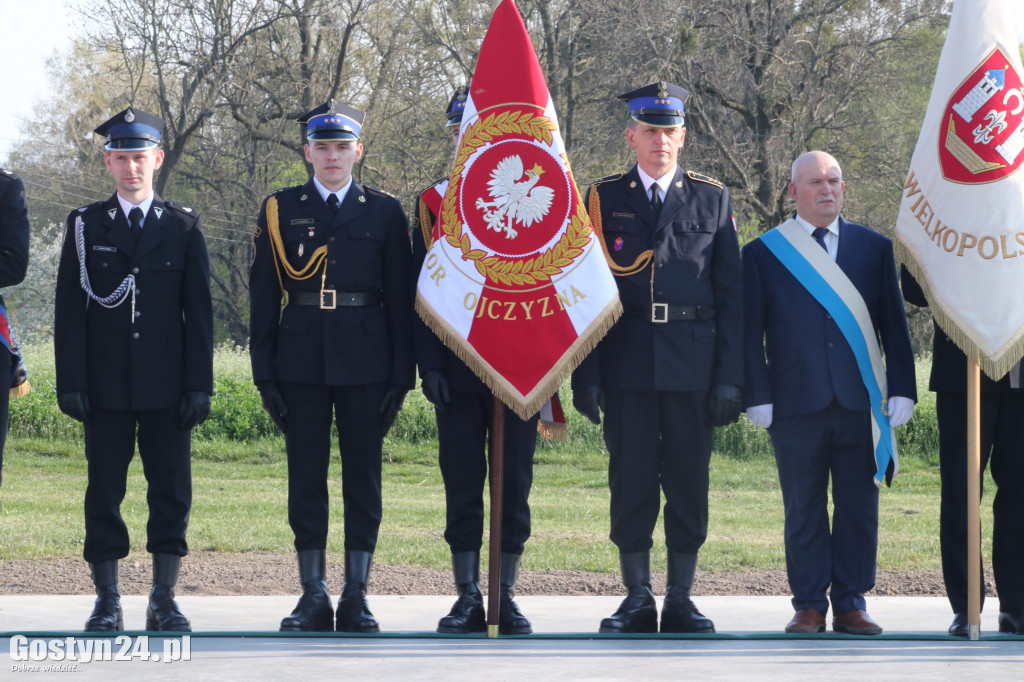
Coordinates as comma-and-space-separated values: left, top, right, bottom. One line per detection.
572, 161, 743, 391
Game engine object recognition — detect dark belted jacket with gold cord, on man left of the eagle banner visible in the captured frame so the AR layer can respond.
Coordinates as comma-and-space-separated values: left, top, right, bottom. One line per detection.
249, 178, 416, 388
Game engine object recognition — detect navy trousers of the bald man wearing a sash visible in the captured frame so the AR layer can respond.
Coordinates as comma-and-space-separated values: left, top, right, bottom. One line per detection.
768, 400, 879, 613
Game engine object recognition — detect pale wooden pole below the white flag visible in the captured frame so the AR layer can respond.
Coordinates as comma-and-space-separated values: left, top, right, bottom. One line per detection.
967, 357, 981, 640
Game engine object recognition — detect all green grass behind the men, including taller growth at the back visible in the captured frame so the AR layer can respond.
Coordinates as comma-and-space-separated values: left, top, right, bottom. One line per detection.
0, 346, 994, 572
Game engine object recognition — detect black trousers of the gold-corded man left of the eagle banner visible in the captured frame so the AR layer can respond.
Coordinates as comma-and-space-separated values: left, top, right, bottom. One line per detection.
281, 382, 387, 552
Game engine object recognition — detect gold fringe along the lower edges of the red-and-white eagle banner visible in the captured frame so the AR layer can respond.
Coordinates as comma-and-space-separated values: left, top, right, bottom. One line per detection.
416, 291, 623, 420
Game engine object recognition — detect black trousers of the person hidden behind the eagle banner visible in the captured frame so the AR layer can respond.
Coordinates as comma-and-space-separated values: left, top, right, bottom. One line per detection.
437, 390, 538, 554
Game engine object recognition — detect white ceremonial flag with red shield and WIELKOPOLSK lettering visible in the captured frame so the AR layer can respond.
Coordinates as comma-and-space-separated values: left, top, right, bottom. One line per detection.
895, 0, 1024, 379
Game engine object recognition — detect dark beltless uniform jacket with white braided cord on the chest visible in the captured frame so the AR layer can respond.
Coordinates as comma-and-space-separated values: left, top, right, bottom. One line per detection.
54, 195, 213, 411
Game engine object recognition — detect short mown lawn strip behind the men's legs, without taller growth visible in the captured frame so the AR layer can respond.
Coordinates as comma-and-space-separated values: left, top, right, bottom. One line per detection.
0, 438, 993, 572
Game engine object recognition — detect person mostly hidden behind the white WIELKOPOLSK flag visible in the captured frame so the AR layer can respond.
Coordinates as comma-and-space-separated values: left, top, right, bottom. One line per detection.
900, 267, 1024, 637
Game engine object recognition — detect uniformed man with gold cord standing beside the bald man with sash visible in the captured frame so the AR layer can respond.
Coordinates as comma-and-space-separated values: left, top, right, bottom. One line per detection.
572, 83, 743, 633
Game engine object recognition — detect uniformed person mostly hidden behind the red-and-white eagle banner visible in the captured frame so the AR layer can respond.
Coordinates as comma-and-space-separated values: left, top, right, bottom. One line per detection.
413, 88, 538, 635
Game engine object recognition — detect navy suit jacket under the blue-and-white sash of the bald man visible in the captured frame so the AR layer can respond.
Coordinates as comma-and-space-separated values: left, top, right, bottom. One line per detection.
743, 217, 918, 417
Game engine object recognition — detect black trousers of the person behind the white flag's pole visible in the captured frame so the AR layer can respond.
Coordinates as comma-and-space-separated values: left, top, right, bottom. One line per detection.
936, 390, 1024, 613
